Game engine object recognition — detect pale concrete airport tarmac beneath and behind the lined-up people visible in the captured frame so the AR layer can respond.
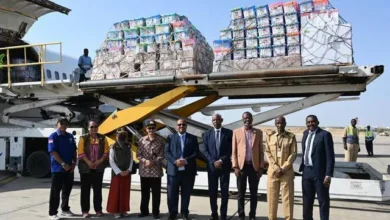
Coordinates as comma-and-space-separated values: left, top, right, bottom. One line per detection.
0, 128, 390, 220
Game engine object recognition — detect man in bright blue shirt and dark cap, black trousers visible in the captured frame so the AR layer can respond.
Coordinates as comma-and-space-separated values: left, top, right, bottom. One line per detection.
48, 119, 77, 220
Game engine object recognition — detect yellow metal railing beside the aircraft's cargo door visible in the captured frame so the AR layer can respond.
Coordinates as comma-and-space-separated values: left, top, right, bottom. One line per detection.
0, 42, 62, 88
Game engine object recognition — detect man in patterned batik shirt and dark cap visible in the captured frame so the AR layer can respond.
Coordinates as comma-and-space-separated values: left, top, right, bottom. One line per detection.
137, 120, 165, 219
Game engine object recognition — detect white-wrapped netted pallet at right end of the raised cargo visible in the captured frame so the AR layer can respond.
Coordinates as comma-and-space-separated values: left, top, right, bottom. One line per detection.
300, 0, 354, 66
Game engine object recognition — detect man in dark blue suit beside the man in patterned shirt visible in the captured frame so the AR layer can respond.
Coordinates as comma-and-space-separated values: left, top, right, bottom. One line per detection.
165, 119, 199, 220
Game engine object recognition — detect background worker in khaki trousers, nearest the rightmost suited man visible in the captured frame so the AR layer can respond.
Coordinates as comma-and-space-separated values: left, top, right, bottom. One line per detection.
343, 119, 360, 162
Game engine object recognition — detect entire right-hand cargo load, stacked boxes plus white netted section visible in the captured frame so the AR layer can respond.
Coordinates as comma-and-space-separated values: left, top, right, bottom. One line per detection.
213, 0, 353, 72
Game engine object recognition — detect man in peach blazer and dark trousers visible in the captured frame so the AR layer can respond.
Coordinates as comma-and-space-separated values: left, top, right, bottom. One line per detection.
232, 112, 264, 220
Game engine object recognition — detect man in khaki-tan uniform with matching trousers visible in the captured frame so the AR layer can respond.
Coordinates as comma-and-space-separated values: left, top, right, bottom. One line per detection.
265, 116, 297, 220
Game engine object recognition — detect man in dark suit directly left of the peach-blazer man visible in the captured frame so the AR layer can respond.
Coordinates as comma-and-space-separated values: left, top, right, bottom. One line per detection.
203, 114, 233, 220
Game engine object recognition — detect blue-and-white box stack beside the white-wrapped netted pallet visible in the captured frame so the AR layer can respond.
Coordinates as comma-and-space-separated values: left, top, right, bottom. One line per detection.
213, 1, 301, 72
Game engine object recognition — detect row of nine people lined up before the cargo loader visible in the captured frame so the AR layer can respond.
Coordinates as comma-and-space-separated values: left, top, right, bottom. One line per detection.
48, 112, 335, 220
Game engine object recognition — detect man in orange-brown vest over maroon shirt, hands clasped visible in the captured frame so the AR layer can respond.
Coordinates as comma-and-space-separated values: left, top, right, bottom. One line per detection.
78, 120, 110, 218
